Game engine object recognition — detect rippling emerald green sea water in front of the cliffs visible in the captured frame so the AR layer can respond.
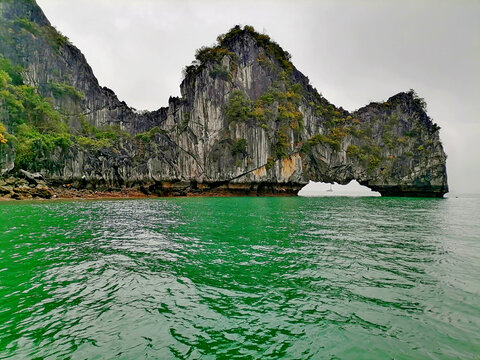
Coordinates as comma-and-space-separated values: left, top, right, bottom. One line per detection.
0, 196, 480, 360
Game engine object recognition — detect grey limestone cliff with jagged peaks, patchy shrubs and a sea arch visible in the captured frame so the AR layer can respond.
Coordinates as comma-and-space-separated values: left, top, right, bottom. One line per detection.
0, 0, 448, 196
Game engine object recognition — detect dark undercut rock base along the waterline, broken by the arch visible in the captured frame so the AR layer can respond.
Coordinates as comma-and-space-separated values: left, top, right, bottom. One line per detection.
0, 176, 446, 200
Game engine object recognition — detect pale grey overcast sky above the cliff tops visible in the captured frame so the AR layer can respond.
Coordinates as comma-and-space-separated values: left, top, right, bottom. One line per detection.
37, 0, 480, 193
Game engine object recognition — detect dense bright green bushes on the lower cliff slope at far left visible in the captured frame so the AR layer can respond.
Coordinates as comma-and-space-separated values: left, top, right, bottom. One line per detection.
0, 55, 134, 171
